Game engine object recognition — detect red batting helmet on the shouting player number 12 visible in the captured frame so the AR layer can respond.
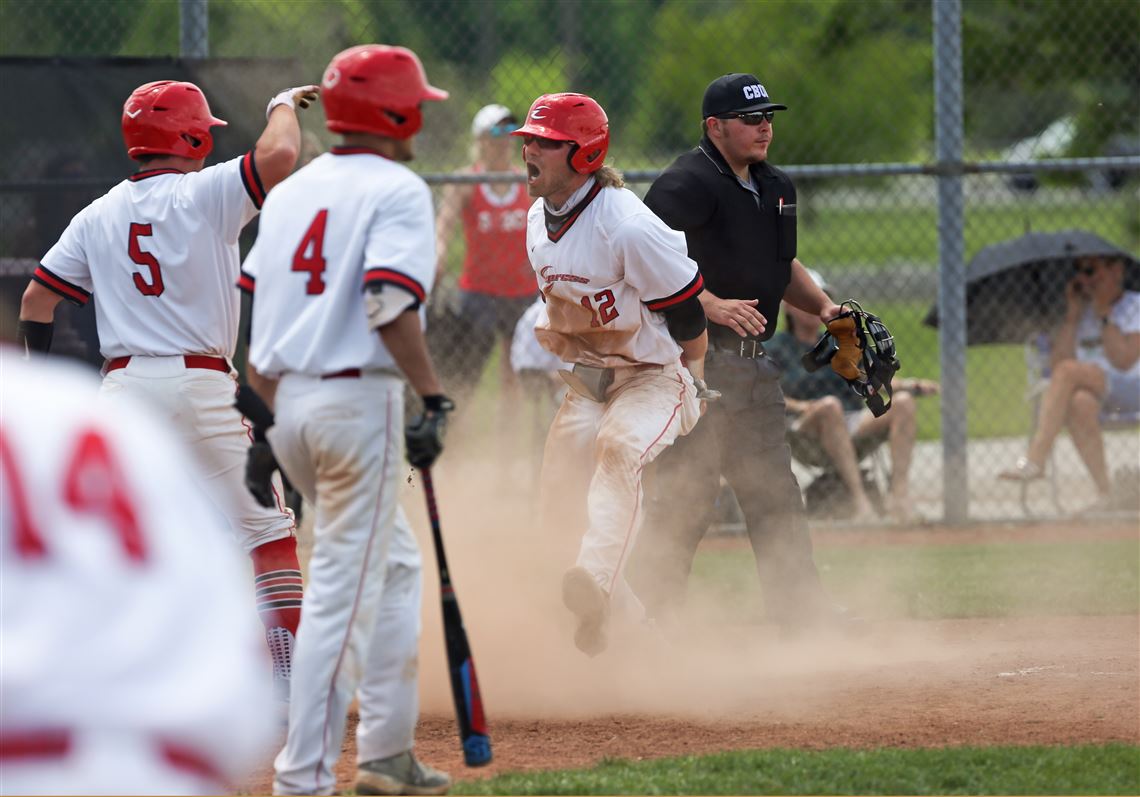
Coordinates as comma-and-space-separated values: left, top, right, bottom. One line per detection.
511, 92, 610, 174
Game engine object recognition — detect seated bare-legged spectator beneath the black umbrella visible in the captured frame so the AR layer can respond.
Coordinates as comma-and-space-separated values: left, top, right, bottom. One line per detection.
1001, 258, 1140, 510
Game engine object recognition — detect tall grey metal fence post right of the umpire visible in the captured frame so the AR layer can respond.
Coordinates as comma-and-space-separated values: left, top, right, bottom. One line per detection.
934, 0, 970, 523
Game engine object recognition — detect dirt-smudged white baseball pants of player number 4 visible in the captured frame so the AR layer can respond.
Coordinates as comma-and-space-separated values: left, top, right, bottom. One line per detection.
269, 373, 422, 795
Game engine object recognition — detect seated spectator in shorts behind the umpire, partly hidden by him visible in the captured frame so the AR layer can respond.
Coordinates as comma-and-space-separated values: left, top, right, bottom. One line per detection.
766, 269, 938, 522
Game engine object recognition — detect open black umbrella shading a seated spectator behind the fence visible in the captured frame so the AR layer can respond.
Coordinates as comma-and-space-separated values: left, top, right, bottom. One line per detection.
923, 229, 1140, 345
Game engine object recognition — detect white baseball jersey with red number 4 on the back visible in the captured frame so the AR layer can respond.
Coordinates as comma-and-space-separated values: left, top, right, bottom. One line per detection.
238, 147, 435, 377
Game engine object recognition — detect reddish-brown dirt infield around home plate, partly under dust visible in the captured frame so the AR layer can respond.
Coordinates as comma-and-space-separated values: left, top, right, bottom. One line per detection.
244, 510, 1140, 794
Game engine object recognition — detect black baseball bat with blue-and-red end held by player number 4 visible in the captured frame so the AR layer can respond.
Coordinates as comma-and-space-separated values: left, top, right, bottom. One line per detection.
421, 467, 491, 766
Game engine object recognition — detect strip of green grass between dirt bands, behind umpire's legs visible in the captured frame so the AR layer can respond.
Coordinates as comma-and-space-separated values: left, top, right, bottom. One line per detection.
693, 539, 1140, 623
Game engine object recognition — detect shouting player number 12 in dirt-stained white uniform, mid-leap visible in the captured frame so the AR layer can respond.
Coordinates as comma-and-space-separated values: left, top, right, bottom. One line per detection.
512, 93, 711, 656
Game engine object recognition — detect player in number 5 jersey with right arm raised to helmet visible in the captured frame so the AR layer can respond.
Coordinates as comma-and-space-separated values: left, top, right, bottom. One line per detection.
19, 81, 316, 700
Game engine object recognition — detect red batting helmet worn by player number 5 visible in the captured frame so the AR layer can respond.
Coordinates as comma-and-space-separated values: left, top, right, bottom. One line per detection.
123, 80, 226, 158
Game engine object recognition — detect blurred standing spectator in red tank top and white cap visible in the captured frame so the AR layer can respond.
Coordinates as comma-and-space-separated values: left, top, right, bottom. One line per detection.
432, 105, 538, 410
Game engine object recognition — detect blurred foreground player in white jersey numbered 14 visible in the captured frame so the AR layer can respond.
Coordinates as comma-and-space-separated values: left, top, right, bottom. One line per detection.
0, 345, 274, 795
